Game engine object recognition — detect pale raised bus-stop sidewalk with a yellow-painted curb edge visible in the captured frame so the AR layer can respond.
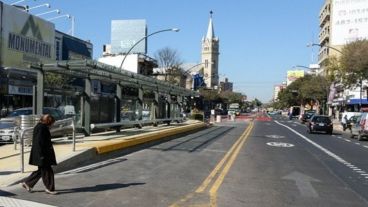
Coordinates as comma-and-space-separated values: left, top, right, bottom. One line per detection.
0, 120, 207, 187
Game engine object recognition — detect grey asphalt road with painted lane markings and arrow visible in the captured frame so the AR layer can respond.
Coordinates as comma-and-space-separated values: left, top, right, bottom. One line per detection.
0, 116, 368, 207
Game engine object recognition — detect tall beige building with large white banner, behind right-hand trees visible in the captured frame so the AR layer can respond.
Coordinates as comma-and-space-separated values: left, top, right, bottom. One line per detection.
318, 0, 368, 115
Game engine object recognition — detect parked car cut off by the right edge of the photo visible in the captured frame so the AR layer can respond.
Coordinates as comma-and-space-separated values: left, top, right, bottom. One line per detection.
349, 112, 368, 141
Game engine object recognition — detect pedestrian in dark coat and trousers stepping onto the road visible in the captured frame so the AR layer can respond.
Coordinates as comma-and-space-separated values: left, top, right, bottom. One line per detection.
21, 114, 57, 195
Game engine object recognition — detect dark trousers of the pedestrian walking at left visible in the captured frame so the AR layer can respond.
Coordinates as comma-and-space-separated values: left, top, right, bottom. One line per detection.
24, 166, 55, 191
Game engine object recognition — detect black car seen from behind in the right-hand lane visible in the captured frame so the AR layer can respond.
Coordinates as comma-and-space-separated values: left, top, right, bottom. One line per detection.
308, 115, 333, 134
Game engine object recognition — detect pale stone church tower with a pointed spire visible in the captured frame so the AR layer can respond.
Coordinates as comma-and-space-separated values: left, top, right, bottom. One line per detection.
202, 11, 220, 88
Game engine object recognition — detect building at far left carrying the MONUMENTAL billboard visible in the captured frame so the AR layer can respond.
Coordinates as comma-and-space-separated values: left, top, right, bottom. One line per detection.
0, 1, 93, 115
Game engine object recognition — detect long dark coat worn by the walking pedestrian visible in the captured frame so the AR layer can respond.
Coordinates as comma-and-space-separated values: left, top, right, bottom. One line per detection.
29, 123, 56, 166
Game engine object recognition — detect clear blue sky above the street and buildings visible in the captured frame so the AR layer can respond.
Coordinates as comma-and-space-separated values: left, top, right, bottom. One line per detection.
4, 0, 324, 102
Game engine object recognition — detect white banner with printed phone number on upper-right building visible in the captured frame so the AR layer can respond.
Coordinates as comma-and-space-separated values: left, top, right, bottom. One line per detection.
331, 0, 368, 45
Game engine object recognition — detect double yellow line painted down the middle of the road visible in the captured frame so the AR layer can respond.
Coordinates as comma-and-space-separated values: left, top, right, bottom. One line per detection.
170, 122, 254, 207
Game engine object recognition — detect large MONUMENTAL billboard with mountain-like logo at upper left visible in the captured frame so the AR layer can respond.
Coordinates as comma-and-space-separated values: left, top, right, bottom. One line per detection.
0, 4, 55, 68
